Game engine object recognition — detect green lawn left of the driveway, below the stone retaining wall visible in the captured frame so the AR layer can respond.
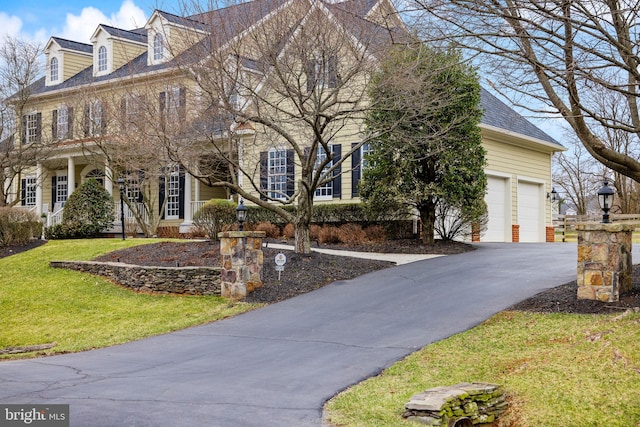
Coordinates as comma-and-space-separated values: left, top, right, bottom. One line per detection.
0, 239, 255, 358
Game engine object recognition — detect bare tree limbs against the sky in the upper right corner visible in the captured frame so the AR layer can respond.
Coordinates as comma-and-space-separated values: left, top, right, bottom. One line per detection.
411, 0, 640, 182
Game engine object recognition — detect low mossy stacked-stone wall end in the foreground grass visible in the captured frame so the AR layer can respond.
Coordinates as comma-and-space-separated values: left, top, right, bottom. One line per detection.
403, 383, 508, 427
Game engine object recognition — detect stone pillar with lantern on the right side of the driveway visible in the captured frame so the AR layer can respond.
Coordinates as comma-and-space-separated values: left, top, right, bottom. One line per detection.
576, 222, 635, 302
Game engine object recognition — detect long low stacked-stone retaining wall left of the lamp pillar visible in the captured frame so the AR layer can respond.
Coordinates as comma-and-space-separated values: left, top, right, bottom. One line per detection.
49, 261, 221, 295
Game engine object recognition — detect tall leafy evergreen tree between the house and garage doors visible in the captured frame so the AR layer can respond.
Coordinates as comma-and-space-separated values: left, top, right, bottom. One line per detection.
360, 44, 487, 243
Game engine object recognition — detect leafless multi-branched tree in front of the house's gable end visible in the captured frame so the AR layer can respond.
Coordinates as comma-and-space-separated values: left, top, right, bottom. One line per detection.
170, 1, 402, 253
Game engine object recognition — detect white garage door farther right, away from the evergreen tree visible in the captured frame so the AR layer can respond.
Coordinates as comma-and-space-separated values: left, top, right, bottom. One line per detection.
518, 181, 544, 242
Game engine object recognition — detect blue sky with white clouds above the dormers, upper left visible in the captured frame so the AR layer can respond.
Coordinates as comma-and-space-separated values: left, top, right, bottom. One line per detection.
0, 0, 180, 44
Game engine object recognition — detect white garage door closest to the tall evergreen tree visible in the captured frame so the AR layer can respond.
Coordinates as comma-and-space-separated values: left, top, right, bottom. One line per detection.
480, 176, 511, 242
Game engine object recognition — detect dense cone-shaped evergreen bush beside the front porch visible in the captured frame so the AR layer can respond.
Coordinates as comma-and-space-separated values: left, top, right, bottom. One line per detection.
45, 178, 114, 239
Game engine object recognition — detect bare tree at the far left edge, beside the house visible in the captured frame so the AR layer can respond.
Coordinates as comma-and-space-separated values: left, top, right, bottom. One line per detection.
0, 37, 50, 206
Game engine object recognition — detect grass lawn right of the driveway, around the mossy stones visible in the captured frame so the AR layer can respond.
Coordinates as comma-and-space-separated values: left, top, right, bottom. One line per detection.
326, 312, 640, 427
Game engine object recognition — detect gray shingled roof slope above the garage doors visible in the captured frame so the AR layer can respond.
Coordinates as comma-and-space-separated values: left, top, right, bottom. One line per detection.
480, 88, 562, 148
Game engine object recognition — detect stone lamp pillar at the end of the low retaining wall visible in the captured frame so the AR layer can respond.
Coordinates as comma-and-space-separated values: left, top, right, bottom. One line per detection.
218, 231, 266, 299
